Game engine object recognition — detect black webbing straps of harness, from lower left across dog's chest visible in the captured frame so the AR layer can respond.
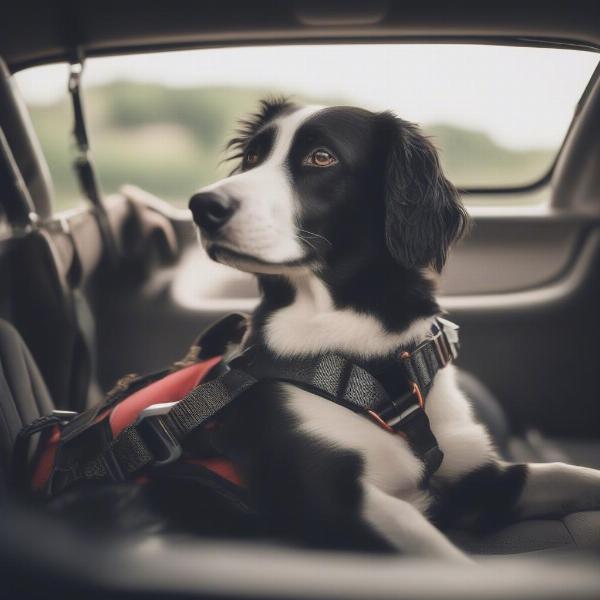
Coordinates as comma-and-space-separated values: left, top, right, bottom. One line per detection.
53, 319, 458, 488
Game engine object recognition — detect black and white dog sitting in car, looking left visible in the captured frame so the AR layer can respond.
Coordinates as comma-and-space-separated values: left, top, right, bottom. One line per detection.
190, 100, 600, 560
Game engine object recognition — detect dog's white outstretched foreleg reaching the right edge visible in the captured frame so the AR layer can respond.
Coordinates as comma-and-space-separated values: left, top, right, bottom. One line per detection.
516, 463, 600, 517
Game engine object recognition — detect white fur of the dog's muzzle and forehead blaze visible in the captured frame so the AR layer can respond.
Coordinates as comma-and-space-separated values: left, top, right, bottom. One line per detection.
199, 106, 321, 272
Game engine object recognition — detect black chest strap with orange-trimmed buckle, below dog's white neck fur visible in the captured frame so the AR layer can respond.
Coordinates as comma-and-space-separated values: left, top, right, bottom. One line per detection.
230, 319, 458, 480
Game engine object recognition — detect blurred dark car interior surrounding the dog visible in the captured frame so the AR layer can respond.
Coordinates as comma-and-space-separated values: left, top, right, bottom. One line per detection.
0, 0, 600, 598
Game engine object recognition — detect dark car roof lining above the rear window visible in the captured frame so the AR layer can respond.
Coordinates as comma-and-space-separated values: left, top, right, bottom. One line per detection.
0, 0, 600, 72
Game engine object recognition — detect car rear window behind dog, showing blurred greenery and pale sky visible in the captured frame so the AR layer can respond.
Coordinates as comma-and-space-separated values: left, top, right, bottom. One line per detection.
17, 44, 598, 206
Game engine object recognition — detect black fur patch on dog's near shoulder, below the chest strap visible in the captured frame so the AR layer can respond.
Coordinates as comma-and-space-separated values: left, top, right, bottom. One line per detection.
214, 382, 390, 551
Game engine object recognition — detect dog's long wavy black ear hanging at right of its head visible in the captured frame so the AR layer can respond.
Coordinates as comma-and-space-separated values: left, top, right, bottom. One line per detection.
382, 113, 469, 272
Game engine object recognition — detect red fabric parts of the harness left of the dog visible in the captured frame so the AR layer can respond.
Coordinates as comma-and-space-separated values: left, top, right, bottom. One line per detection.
32, 356, 242, 491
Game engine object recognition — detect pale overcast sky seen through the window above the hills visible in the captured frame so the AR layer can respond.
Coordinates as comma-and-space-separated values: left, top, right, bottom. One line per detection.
17, 45, 598, 148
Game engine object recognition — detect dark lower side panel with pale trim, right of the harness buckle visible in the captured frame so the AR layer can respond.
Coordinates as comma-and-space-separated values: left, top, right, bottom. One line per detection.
444, 229, 600, 438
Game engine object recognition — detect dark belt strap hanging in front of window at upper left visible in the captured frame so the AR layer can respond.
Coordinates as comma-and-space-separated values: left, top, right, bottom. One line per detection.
68, 48, 118, 266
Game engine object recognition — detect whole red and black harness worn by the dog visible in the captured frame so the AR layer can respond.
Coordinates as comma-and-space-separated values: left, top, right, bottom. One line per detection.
14, 314, 459, 495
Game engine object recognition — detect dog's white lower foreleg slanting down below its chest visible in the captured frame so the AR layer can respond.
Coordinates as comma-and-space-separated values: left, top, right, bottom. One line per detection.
363, 483, 472, 563
